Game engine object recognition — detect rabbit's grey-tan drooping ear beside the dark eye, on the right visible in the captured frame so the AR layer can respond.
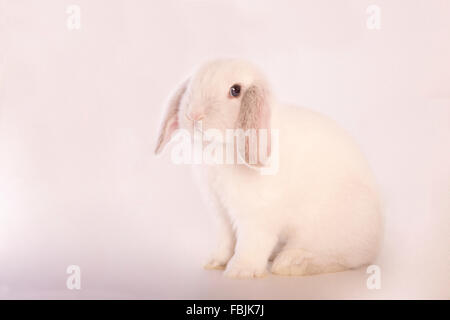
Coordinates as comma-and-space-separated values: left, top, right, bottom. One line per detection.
237, 84, 271, 166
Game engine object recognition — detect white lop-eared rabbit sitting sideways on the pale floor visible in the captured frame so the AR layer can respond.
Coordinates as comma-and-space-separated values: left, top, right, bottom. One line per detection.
155, 59, 382, 278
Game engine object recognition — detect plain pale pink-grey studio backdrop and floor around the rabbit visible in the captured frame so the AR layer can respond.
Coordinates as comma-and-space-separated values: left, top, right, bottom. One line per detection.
0, 0, 450, 299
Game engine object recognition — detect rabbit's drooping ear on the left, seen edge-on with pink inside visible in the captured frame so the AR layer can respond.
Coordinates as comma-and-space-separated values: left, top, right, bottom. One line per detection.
155, 79, 189, 154
